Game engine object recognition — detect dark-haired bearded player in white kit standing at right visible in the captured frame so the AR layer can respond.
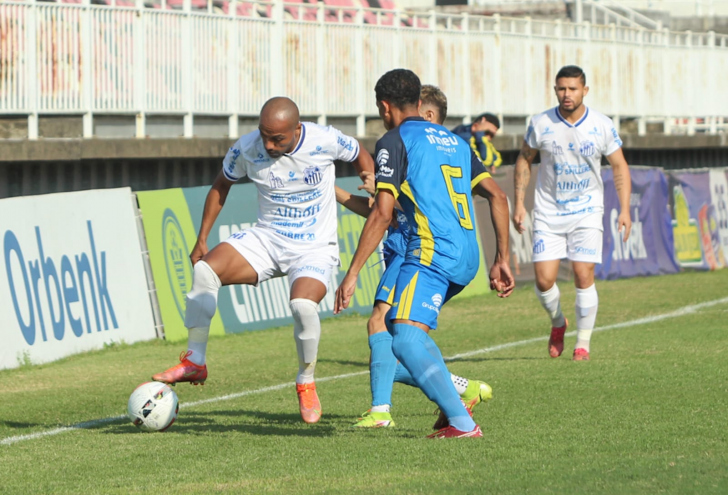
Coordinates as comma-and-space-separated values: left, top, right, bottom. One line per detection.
513, 65, 632, 361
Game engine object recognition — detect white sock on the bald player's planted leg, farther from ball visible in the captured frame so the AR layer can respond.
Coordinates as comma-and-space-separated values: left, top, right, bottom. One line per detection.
289, 298, 321, 384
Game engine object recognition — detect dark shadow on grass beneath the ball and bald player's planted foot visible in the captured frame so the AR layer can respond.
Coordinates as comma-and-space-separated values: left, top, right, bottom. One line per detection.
99, 410, 343, 437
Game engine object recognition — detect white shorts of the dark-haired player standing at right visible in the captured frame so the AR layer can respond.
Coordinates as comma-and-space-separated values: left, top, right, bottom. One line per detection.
533, 228, 602, 263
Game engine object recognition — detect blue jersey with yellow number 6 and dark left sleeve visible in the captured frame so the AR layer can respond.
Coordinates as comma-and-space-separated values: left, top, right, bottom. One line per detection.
375, 117, 488, 285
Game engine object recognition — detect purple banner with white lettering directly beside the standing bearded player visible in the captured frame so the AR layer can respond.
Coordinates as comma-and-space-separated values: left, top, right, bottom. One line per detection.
595, 167, 680, 280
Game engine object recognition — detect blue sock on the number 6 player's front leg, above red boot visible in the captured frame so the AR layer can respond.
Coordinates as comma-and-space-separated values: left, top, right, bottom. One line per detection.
392, 323, 475, 431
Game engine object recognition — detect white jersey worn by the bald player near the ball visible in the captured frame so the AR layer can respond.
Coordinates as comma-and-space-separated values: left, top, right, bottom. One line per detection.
222, 122, 359, 252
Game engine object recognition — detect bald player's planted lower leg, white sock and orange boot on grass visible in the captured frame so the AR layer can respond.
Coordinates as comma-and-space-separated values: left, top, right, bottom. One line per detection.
289, 298, 321, 423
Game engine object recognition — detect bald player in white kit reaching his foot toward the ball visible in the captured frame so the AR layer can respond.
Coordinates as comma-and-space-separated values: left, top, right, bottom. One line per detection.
152, 97, 374, 423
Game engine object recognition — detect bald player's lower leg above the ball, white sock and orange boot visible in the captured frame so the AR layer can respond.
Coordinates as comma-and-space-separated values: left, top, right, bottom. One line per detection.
152, 261, 221, 385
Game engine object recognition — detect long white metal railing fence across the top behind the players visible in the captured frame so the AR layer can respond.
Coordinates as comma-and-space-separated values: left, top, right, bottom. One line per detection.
0, 0, 728, 139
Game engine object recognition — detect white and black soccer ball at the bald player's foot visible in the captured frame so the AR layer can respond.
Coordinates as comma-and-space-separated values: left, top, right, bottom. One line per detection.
126, 382, 179, 431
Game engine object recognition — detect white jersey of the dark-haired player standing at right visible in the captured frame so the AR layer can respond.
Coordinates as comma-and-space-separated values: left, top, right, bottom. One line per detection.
525, 107, 622, 233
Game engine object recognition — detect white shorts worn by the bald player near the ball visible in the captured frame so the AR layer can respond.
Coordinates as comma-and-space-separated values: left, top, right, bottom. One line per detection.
223, 227, 340, 289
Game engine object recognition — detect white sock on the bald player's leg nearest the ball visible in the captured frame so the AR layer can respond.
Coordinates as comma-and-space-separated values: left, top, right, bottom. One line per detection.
185, 261, 222, 366
